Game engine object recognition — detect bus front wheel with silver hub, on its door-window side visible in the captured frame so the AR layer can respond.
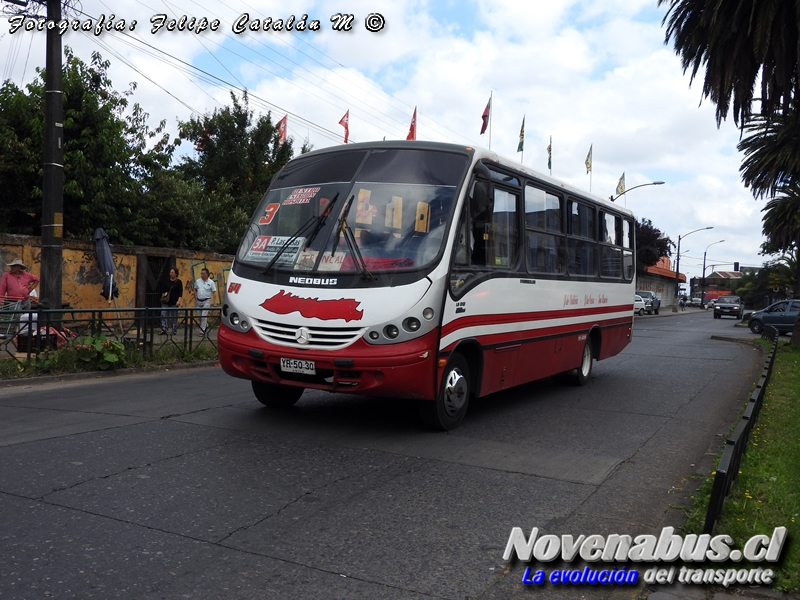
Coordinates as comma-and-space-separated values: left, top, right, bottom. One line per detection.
419, 354, 472, 431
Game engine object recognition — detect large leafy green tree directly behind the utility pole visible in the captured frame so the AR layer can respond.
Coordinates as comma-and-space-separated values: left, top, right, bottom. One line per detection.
0, 48, 173, 244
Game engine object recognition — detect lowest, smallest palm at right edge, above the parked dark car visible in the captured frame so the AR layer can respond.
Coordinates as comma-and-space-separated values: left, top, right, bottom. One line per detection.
762, 186, 800, 346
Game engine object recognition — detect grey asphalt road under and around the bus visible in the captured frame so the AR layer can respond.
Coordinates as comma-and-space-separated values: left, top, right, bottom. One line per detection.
0, 311, 761, 600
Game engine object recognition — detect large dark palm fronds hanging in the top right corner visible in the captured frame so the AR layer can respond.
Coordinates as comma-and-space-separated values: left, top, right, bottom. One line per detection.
658, 0, 800, 126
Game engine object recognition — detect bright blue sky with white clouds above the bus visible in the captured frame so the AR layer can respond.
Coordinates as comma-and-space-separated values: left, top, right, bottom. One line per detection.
0, 0, 766, 284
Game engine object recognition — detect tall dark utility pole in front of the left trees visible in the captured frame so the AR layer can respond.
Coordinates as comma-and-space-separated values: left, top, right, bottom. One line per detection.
41, 0, 64, 310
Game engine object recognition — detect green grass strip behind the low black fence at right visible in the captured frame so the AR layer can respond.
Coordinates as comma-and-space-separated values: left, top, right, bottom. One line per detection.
684, 343, 800, 592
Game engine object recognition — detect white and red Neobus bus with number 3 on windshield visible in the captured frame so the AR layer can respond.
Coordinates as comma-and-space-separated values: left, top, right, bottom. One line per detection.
219, 141, 635, 429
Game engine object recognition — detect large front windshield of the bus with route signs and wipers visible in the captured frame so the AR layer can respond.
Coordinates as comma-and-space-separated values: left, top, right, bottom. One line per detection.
237, 149, 469, 273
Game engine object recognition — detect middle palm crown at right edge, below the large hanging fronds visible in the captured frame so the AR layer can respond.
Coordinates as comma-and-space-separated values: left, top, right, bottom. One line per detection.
738, 109, 800, 198
